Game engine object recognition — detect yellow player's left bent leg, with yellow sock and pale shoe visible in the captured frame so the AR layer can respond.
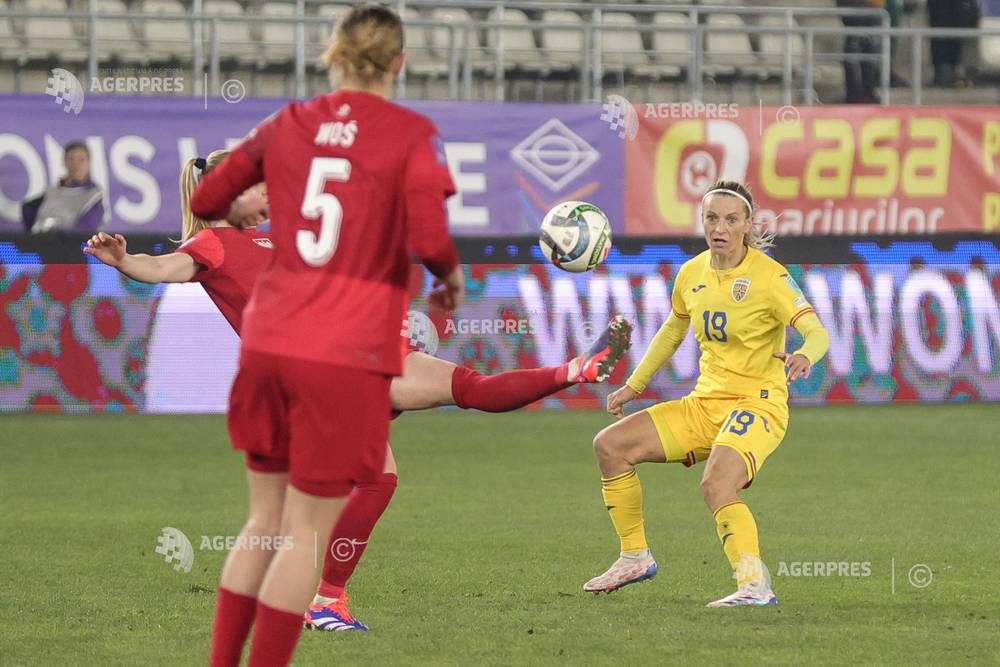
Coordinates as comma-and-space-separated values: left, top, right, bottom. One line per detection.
583, 411, 666, 593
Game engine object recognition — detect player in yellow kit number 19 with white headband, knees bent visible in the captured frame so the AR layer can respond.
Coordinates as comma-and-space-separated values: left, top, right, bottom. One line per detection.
583, 181, 829, 607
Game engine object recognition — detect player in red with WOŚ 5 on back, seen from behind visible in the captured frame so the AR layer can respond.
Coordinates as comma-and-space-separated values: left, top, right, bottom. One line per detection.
191, 5, 464, 667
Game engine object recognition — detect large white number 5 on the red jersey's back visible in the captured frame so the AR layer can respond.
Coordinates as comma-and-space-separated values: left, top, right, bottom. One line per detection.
295, 157, 351, 266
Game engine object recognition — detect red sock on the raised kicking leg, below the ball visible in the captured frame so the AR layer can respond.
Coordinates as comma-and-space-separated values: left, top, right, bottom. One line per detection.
451, 364, 573, 412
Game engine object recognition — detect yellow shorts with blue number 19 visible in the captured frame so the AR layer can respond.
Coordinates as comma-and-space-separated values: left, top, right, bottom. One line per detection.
645, 396, 788, 488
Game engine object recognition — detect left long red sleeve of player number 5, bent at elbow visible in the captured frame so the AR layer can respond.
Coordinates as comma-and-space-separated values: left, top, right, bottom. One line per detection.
191, 112, 281, 220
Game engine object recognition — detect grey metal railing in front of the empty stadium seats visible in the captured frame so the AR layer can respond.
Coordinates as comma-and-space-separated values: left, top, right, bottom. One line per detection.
0, 0, 1000, 104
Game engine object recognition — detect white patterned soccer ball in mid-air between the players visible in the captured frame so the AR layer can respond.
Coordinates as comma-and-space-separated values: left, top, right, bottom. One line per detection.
538, 201, 611, 273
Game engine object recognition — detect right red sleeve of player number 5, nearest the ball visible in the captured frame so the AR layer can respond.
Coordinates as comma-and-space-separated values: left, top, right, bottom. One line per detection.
403, 125, 458, 278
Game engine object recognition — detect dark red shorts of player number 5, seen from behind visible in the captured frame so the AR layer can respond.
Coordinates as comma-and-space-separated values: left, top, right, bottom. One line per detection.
229, 350, 391, 497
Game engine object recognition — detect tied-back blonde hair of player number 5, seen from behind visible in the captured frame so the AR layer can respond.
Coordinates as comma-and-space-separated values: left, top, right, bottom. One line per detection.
322, 5, 403, 84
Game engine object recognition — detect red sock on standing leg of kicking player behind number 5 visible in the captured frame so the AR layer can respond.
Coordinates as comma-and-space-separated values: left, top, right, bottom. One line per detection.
317, 472, 397, 598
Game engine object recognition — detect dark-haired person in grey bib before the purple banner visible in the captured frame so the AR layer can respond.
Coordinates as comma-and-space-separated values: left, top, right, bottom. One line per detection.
21, 141, 104, 234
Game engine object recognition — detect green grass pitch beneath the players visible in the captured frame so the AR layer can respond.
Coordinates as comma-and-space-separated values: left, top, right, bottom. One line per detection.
0, 405, 1000, 666
